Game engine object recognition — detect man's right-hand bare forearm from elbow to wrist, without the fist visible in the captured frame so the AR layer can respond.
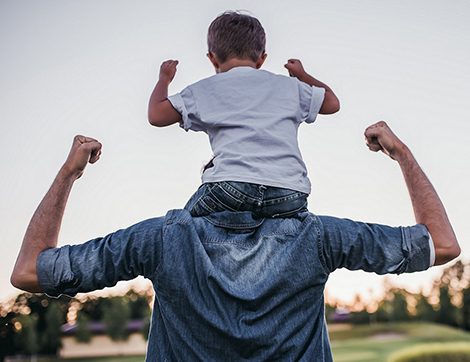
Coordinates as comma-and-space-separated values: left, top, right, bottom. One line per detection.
395, 145, 460, 265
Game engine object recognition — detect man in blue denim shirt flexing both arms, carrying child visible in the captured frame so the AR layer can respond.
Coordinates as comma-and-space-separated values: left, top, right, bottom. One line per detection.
11, 122, 460, 361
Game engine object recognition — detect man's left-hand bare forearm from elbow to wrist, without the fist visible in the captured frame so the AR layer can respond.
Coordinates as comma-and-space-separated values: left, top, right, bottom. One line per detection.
11, 168, 76, 292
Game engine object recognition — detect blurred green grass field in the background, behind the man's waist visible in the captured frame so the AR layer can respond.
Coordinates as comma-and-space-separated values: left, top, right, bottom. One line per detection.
9, 323, 470, 362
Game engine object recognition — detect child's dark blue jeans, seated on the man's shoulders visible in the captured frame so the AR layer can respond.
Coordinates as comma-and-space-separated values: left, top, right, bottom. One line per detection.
184, 181, 308, 218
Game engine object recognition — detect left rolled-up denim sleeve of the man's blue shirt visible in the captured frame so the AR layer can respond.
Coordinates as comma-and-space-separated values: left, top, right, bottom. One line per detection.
37, 218, 163, 297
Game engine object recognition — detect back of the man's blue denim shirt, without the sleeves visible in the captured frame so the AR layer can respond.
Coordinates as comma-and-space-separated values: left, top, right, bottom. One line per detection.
151, 212, 330, 361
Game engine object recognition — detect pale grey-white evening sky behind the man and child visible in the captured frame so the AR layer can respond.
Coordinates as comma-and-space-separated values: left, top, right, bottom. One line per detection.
0, 0, 470, 303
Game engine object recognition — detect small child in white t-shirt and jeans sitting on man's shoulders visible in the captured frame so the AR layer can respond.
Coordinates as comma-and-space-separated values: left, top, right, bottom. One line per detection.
148, 12, 339, 217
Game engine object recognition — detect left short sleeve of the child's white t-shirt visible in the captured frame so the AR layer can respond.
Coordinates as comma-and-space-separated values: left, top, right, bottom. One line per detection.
168, 87, 205, 132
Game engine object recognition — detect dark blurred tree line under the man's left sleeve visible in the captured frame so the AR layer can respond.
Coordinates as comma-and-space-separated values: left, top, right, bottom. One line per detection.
0, 289, 153, 361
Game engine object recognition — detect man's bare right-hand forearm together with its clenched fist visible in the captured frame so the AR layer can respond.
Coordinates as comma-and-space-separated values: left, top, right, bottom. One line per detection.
365, 121, 460, 265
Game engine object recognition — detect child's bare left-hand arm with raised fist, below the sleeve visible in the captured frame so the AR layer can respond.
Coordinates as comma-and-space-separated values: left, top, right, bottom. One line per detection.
148, 60, 181, 127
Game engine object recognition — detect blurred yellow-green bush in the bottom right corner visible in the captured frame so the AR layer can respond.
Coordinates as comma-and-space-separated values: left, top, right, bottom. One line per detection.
388, 343, 470, 362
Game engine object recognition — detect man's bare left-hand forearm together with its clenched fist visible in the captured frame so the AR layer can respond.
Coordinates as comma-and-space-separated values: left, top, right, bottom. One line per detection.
11, 136, 101, 292
